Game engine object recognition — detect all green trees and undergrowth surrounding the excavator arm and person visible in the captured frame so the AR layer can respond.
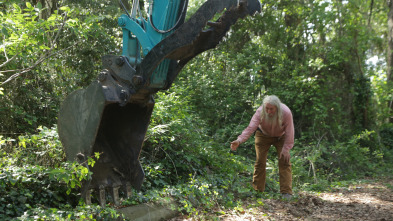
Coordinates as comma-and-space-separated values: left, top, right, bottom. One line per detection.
0, 0, 393, 220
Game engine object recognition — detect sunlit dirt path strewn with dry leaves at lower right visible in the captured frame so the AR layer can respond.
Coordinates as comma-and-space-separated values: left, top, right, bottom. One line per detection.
171, 179, 393, 221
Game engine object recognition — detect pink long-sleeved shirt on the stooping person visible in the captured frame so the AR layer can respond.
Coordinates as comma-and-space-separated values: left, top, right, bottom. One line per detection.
237, 104, 295, 150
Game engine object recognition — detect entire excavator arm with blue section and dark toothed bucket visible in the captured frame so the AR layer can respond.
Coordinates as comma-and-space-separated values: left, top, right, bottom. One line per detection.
58, 0, 261, 205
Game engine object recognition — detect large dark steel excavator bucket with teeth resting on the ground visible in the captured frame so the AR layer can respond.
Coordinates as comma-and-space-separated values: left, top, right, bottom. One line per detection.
58, 82, 154, 205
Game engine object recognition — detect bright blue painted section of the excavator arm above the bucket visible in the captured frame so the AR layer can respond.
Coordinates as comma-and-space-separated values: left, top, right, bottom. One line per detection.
118, 0, 187, 88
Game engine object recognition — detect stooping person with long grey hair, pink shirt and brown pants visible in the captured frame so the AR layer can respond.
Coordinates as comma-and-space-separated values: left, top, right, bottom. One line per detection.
231, 95, 294, 199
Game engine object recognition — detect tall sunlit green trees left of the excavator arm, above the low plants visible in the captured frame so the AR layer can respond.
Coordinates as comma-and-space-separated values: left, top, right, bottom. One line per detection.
0, 1, 121, 135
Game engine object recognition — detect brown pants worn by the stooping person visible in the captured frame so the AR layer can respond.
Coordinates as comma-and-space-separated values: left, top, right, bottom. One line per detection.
252, 130, 292, 194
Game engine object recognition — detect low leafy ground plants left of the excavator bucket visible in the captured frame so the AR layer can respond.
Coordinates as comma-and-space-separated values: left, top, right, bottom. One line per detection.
0, 127, 124, 220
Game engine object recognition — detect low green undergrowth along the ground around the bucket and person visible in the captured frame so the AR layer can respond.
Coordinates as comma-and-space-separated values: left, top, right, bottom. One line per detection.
0, 122, 393, 220
